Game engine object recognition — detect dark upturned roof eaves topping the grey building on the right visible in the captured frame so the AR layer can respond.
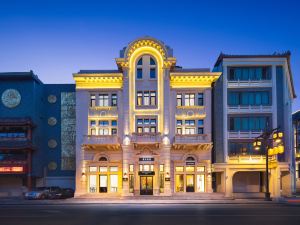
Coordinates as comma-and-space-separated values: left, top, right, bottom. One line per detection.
214, 51, 297, 98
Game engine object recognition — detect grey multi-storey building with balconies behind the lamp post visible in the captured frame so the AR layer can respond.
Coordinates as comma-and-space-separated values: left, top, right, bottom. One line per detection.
213, 52, 296, 197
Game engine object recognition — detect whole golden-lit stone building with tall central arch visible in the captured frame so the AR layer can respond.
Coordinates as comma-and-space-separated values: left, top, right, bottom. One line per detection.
74, 37, 221, 197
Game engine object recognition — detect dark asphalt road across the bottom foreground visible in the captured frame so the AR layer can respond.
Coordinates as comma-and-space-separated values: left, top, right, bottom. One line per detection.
0, 204, 300, 225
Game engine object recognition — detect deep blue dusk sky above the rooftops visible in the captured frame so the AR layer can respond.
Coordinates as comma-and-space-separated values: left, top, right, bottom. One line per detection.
0, 0, 300, 111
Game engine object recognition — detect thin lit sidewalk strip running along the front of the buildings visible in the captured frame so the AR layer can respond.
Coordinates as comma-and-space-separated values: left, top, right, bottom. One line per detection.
0, 197, 288, 205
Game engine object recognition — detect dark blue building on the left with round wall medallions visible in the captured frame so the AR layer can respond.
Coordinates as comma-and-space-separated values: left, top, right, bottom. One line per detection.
0, 71, 75, 196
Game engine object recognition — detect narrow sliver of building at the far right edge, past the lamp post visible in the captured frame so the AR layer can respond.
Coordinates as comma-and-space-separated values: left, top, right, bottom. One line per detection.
293, 111, 300, 193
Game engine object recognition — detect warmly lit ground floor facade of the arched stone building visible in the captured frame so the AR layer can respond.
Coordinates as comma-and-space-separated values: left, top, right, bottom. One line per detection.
75, 145, 212, 197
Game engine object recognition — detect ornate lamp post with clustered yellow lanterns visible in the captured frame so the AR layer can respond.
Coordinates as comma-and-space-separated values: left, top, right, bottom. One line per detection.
253, 128, 284, 201
